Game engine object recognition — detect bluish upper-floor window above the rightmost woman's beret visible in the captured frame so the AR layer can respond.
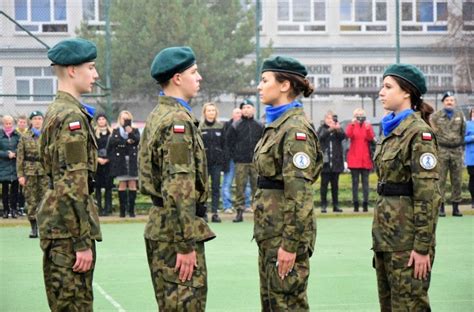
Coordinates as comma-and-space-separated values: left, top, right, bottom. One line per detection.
401, 0, 448, 32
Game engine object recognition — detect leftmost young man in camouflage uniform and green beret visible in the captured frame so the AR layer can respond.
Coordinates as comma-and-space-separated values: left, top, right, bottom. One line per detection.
37, 38, 102, 311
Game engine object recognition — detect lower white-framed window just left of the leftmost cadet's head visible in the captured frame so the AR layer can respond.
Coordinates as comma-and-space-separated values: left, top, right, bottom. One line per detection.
15, 67, 57, 102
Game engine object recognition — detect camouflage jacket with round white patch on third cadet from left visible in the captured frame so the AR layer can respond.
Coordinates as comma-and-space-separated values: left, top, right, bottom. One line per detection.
253, 108, 323, 253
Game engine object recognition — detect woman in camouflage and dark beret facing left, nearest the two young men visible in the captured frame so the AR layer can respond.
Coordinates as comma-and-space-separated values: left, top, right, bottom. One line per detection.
254, 56, 322, 311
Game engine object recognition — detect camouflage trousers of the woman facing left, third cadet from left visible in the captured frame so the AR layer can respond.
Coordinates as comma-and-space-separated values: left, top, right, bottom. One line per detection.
258, 238, 309, 312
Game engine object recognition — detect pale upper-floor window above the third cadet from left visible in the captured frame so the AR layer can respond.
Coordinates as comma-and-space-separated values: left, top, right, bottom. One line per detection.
277, 0, 326, 33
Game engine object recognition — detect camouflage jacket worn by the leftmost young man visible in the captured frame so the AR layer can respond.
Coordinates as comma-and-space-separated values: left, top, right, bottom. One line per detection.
37, 91, 102, 251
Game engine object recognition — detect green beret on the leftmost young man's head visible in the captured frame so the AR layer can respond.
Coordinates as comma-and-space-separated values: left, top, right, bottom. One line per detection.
48, 38, 97, 65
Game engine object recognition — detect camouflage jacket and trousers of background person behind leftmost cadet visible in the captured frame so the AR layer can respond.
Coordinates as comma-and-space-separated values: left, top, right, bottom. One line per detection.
16, 130, 48, 221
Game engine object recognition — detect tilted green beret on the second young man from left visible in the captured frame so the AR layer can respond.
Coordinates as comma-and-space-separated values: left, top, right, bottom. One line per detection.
150, 47, 196, 82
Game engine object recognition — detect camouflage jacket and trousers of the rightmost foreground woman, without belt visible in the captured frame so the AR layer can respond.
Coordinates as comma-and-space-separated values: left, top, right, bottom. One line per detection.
372, 113, 441, 311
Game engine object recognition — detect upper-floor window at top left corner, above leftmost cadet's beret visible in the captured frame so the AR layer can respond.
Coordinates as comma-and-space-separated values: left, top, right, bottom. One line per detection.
15, 0, 68, 33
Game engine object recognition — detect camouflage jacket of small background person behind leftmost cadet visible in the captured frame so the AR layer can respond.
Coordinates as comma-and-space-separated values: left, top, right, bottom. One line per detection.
16, 130, 45, 177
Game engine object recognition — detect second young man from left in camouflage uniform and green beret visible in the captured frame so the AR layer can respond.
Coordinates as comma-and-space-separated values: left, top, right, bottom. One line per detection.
138, 47, 215, 312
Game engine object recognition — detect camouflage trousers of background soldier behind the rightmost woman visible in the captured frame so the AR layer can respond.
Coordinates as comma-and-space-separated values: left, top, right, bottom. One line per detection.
438, 147, 464, 203
